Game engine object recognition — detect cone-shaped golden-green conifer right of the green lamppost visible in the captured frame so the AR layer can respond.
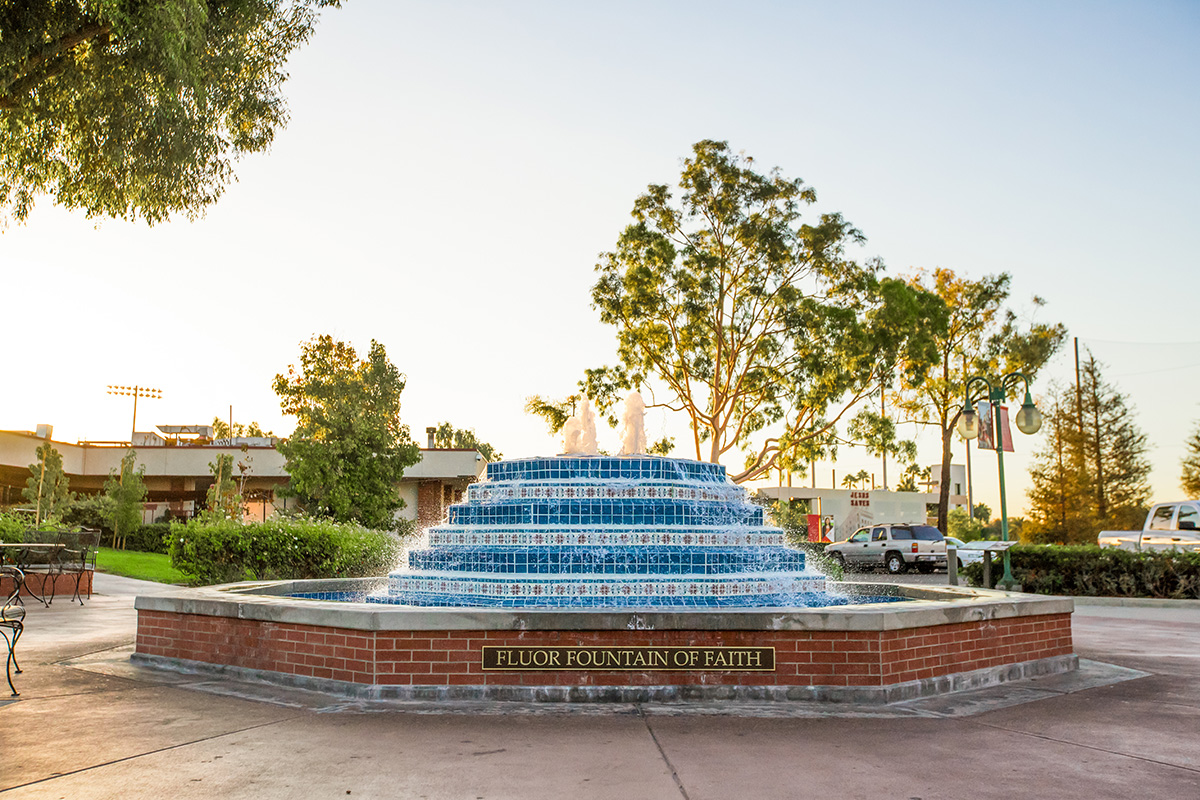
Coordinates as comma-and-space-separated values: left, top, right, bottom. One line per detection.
1026, 355, 1150, 543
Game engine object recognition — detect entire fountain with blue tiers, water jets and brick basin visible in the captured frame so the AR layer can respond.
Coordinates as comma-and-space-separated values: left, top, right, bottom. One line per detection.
133, 395, 1078, 703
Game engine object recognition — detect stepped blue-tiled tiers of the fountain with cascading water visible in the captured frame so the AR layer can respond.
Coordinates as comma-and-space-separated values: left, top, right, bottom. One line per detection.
388, 456, 829, 608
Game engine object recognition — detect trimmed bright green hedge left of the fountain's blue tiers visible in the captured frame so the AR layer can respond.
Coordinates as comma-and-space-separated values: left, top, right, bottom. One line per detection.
170, 517, 402, 584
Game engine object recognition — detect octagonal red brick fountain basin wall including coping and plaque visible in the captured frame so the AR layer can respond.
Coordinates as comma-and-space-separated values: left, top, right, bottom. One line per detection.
134, 581, 1078, 703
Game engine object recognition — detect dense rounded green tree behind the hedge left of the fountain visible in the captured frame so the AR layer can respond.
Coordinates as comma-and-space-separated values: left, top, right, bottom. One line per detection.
275, 335, 421, 530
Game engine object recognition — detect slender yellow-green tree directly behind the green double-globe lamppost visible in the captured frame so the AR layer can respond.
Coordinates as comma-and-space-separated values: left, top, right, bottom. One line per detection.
893, 269, 1067, 530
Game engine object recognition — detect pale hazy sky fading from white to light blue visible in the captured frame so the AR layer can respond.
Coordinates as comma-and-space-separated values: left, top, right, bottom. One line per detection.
0, 0, 1200, 513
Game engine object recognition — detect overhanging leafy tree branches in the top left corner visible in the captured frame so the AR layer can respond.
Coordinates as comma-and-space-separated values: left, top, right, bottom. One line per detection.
0, 0, 340, 224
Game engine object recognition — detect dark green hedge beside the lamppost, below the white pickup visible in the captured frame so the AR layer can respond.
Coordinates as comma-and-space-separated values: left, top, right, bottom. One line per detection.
962, 545, 1200, 599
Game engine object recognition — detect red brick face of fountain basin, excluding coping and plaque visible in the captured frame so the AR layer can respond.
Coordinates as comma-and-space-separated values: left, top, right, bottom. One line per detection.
137, 610, 1072, 686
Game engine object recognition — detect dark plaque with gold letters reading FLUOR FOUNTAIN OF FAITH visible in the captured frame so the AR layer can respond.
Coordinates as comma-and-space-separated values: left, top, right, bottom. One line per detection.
484, 645, 775, 672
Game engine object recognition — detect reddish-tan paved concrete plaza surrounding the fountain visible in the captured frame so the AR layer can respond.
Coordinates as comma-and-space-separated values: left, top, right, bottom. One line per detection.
0, 575, 1200, 800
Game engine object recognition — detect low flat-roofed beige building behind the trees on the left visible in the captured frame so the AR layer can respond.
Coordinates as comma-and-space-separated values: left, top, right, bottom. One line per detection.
0, 425, 487, 525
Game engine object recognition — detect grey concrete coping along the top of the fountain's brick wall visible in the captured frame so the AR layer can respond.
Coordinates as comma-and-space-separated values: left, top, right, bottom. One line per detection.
134, 578, 1074, 631
